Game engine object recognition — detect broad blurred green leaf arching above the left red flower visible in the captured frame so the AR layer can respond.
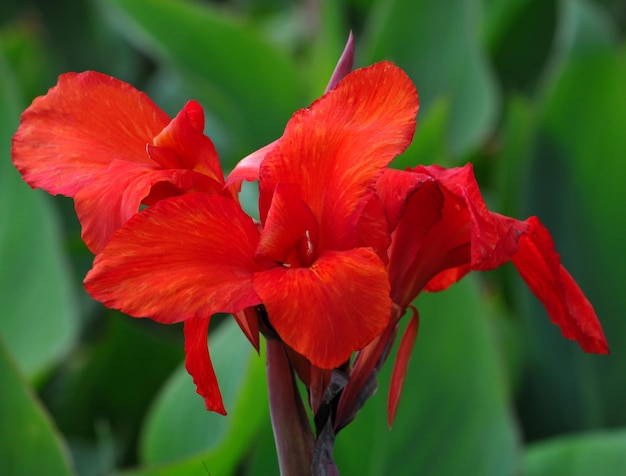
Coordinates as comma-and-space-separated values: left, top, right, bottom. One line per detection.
101, 0, 302, 160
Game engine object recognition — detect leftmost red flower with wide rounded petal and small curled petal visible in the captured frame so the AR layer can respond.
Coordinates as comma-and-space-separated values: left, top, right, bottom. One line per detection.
13, 71, 228, 253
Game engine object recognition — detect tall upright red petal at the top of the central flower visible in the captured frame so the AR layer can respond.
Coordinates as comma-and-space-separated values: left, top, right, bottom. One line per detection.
259, 63, 418, 249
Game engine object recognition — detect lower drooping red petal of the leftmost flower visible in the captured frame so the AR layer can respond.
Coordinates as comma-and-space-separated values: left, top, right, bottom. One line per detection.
75, 160, 222, 254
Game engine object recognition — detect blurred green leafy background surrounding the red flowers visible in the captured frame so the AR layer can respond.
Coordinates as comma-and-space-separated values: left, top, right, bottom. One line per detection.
0, 0, 626, 476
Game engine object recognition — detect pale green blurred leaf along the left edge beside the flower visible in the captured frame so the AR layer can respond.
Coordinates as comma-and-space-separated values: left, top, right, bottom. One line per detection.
0, 45, 78, 378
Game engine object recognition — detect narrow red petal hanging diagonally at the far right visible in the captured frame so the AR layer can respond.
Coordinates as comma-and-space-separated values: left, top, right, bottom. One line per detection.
513, 217, 609, 354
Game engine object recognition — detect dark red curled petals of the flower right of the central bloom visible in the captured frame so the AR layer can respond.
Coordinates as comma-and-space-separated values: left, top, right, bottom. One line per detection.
390, 164, 527, 298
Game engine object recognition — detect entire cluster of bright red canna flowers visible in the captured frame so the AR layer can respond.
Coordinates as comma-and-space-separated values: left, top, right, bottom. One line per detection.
13, 39, 608, 452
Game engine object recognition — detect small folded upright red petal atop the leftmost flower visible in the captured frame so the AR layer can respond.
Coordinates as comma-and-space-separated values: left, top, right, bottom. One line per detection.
148, 101, 224, 184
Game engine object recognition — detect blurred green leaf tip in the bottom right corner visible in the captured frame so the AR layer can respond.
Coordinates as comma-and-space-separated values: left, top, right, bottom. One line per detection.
524, 429, 626, 476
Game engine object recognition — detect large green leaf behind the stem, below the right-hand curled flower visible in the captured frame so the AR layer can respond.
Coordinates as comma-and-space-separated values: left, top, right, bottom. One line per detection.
335, 277, 521, 476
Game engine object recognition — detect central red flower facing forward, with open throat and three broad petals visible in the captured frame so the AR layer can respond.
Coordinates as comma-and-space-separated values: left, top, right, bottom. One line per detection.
79, 63, 418, 412
